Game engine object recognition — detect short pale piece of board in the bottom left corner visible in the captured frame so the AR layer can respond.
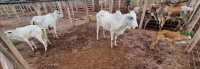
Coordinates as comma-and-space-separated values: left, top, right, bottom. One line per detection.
0, 51, 14, 69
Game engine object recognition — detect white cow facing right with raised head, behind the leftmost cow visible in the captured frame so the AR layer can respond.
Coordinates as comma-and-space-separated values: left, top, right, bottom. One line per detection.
30, 10, 63, 38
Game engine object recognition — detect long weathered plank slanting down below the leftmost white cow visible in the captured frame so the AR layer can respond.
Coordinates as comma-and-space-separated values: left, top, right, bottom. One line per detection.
0, 29, 30, 69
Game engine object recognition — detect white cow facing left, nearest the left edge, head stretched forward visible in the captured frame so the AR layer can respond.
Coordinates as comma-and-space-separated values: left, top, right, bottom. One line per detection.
4, 25, 47, 51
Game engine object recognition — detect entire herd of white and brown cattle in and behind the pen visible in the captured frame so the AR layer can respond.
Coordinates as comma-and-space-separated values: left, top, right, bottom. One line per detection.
4, 1, 193, 51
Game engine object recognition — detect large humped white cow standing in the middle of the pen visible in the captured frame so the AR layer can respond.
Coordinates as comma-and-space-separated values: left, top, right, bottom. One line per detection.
96, 10, 138, 48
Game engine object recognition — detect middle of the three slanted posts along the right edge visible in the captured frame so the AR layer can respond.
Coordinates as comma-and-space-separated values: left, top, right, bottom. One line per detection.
186, 9, 200, 32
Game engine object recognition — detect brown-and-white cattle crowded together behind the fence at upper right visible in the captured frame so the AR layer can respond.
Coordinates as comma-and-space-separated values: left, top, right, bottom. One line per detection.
134, 0, 193, 30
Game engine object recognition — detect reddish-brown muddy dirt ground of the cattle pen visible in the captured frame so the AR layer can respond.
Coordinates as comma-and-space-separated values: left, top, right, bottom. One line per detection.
0, 11, 199, 69
